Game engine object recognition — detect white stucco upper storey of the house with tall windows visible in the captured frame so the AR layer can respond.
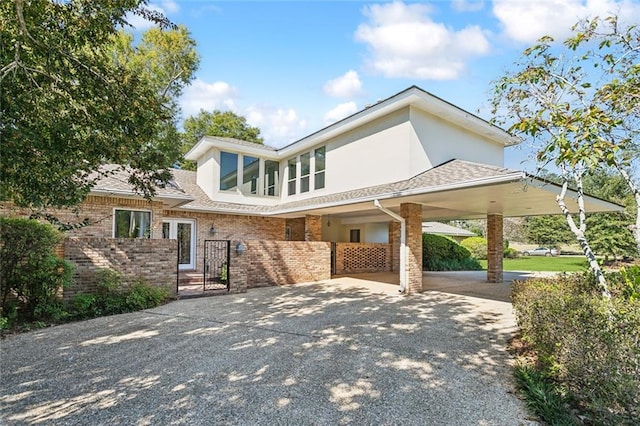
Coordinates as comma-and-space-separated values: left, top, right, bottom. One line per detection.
186, 87, 515, 205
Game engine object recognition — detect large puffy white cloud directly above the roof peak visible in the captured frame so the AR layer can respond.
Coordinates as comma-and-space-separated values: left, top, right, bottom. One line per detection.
355, 2, 489, 80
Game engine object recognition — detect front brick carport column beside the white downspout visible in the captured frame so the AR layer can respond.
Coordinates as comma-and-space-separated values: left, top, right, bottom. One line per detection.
400, 203, 422, 293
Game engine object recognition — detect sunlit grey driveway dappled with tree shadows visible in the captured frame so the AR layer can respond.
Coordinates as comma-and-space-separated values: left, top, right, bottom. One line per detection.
0, 277, 533, 425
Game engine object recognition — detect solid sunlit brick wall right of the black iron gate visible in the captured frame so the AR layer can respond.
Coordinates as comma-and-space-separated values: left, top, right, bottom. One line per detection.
244, 240, 331, 288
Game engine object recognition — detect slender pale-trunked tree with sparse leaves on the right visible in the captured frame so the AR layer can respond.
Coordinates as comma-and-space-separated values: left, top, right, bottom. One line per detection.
493, 17, 640, 296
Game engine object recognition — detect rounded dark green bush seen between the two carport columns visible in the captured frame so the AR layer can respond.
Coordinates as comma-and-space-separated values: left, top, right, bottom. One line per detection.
422, 233, 482, 271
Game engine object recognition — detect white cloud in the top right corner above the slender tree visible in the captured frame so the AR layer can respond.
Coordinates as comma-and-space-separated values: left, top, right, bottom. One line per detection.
493, 0, 640, 43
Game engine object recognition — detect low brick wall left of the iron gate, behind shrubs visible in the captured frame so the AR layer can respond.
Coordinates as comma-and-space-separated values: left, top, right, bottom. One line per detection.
64, 238, 178, 300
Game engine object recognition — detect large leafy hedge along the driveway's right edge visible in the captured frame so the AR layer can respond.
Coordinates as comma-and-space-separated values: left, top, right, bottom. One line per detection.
513, 274, 640, 424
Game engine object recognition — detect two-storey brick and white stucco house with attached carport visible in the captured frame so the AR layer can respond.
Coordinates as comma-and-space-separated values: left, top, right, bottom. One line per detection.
2, 86, 620, 298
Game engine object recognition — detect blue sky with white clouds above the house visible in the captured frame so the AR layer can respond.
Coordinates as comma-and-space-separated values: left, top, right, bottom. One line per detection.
127, 0, 640, 170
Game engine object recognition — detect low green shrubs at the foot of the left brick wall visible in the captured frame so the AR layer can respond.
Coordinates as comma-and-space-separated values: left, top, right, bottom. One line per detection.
71, 269, 169, 319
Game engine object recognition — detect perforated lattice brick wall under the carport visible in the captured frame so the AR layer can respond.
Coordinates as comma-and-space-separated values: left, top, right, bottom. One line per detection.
335, 243, 393, 274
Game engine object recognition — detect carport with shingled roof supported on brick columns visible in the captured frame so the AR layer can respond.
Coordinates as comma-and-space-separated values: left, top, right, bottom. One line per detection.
272, 160, 622, 293
